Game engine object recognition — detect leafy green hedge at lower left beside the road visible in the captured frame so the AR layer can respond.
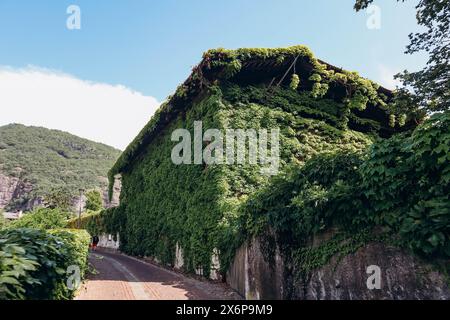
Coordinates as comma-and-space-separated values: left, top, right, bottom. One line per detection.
0, 229, 90, 300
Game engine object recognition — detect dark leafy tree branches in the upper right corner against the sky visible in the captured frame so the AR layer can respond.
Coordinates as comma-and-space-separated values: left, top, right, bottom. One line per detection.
354, 0, 450, 112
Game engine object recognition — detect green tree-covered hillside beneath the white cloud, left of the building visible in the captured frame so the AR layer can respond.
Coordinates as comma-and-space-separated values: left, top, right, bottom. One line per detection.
0, 124, 120, 209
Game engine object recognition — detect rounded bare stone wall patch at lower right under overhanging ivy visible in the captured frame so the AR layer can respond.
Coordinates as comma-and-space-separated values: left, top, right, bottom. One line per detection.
297, 243, 450, 300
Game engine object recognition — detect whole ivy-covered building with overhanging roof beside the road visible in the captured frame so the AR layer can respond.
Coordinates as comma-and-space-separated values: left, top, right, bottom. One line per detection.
105, 46, 446, 300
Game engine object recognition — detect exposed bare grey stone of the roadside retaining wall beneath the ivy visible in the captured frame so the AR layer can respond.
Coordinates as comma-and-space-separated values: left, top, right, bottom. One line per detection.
226, 236, 450, 300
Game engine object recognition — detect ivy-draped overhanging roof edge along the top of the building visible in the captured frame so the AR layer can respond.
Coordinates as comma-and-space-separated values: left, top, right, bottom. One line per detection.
109, 46, 405, 192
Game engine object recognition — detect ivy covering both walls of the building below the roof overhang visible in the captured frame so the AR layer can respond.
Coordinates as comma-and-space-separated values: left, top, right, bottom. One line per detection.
103, 82, 380, 271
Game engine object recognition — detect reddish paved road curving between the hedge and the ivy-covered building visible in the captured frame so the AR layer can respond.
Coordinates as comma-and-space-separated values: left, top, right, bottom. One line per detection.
76, 251, 240, 300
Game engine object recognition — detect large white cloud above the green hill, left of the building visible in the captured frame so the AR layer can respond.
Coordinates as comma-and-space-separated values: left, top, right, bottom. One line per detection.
0, 67, 159, 150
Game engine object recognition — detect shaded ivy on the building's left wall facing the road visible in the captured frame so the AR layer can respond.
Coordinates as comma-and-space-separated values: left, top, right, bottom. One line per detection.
115, 95, 221, 271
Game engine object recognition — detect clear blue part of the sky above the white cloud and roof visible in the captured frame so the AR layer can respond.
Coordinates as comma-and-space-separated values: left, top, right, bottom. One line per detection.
0, 0, 424, 100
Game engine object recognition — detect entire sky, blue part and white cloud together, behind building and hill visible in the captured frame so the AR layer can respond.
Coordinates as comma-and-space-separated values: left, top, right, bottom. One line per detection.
0, 0, 426, 148
